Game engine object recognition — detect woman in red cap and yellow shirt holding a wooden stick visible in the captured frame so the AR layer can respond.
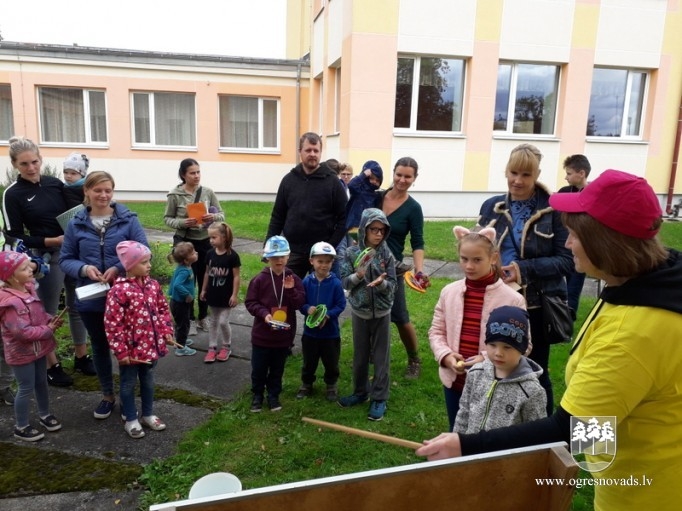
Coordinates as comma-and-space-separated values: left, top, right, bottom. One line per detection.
416, 170, 682, 511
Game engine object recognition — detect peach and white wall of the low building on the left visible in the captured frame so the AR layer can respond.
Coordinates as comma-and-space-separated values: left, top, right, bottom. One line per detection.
0, 43, 309, 199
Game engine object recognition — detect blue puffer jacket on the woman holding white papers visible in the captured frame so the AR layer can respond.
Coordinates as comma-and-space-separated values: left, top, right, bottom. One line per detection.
59, 203, 148, 312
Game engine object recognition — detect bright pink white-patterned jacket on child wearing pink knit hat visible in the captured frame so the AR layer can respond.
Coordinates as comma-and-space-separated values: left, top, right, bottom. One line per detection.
104, 277, 173, 362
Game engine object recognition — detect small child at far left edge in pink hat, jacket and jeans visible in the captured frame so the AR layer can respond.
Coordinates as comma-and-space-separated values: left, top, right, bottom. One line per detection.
0, 252, 62, 442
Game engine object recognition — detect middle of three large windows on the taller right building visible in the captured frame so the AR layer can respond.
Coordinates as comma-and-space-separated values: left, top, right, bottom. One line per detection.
493, 64, 559, 135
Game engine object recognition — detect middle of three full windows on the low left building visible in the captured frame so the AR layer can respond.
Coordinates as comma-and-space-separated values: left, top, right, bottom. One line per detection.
133, 92, 197, 147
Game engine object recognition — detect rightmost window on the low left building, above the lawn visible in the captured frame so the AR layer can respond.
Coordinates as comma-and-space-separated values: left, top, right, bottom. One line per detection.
220, 96, 279, 151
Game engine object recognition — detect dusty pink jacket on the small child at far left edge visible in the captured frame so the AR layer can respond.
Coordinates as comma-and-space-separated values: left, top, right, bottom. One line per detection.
0, 283, 56, 366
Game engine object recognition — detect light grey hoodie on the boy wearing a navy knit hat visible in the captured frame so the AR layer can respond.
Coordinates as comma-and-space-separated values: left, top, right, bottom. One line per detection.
453, 357, 547, 434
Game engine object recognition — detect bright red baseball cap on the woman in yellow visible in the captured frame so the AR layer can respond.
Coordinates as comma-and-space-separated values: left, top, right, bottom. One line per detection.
549, 169, 663, 239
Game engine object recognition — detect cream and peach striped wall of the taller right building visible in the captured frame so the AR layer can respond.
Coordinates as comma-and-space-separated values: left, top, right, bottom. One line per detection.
311, 0, 682, 217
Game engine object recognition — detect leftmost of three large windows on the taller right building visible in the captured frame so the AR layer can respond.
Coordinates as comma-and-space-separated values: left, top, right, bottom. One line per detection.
393, 57, 464, 132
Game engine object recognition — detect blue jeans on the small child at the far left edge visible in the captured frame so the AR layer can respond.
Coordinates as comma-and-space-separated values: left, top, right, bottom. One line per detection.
11, 357, 50, 429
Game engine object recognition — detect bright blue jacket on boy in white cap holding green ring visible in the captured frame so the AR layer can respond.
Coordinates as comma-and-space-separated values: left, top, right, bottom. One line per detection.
300, 272, 346, 339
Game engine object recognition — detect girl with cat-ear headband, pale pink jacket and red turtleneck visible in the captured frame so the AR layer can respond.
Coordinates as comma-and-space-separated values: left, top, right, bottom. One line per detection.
429, 226, 526, 431
